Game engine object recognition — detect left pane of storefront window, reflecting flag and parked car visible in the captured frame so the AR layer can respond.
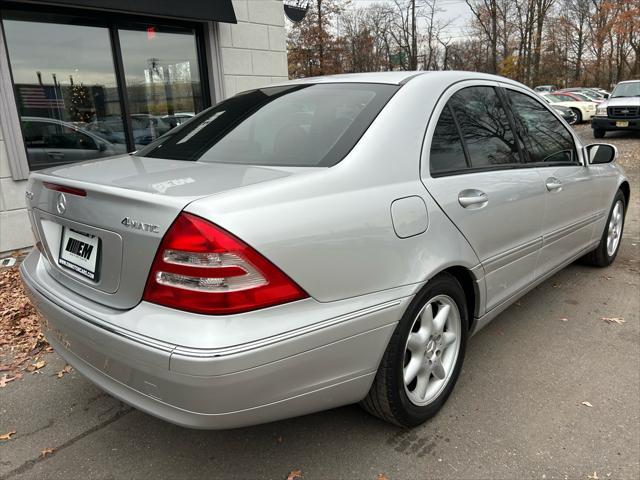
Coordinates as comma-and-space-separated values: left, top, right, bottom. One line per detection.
3, 15, 126, 170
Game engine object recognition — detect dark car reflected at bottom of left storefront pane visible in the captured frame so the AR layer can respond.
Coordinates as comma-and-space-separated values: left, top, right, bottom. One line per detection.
21, 117, 121, 170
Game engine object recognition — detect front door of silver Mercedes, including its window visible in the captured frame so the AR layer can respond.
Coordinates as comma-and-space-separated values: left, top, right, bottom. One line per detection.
505, 86, 606, 277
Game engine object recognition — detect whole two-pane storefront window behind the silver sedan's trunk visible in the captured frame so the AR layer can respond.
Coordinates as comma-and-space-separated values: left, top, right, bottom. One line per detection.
2, 10, 208, 170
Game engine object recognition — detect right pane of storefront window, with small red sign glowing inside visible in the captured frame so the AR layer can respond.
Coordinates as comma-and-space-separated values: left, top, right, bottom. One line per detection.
118, 25, 203, 148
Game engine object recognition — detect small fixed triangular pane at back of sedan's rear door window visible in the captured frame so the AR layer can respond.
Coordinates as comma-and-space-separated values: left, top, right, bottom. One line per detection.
429, 106, 467, 174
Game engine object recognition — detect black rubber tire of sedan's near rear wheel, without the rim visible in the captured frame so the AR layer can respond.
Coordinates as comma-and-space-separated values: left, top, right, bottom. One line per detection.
360, 273, 469, 427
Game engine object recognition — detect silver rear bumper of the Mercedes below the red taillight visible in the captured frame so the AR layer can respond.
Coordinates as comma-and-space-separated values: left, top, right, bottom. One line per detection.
21, 251, 410, 429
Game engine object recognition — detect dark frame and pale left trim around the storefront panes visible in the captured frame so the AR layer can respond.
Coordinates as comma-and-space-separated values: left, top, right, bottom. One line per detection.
0, 0, 215, 176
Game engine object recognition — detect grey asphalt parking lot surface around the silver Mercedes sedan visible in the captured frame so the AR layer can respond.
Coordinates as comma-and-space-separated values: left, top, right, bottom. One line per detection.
0, 125, 640, 480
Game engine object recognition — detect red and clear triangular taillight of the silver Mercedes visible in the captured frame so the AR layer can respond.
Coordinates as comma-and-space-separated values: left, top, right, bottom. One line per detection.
144, 213, 308, 315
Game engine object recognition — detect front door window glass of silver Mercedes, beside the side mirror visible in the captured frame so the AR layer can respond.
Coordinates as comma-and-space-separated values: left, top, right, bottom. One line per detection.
507, 90, 578, 164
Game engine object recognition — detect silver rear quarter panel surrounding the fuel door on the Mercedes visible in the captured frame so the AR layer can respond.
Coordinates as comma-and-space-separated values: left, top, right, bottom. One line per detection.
186, 75, 478, 302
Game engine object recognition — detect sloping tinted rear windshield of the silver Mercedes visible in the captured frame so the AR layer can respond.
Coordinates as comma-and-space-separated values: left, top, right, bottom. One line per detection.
136, 83, 399, 167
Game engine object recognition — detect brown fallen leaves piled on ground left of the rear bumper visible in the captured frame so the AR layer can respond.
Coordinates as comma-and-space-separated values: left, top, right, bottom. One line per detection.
0, 267, 51, 388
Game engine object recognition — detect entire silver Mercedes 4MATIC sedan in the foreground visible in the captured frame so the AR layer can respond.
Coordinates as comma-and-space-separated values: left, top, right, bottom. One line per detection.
21, 72, 629, 428
